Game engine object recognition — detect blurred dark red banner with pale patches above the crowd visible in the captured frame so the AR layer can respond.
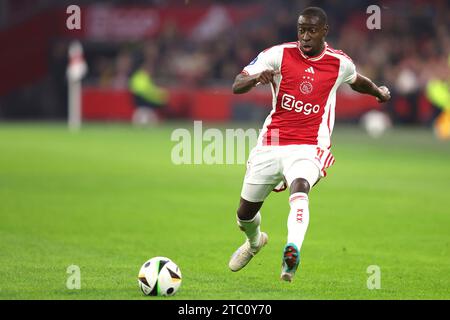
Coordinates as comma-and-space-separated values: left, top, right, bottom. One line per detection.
84, 5, 262, 41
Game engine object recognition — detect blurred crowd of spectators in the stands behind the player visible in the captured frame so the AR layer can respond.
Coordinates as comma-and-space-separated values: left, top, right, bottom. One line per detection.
79, 0, 450, 124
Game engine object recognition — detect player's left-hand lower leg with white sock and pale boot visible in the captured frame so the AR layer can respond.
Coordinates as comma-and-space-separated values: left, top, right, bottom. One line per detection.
228, 198, 268, 272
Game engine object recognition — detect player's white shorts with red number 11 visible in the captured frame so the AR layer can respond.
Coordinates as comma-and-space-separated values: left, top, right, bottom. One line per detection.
241, 145, 334, 202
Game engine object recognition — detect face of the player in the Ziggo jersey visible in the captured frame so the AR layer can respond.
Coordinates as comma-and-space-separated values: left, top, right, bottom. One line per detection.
298, 16, 328, 56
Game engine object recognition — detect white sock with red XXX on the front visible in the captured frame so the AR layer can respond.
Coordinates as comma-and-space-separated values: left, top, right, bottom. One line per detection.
288, 192, 309, 250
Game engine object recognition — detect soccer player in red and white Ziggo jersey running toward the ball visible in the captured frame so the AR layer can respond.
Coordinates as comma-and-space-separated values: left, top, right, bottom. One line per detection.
229, 7, 390, 281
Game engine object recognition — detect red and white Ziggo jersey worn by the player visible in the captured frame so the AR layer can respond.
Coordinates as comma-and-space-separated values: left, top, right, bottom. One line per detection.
242, 42, 357, 149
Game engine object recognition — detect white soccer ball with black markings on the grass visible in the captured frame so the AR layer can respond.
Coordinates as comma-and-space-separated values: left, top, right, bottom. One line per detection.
138, 257, 181, 296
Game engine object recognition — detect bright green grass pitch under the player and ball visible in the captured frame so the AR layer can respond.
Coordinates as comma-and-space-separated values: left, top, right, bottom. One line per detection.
0, 123, 450, 299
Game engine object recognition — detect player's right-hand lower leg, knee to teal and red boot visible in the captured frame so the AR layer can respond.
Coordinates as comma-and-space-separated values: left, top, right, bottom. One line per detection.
281, 178, 310, 282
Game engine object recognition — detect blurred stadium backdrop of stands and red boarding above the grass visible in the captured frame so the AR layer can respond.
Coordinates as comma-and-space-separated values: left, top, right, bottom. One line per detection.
0, 0, 450, 126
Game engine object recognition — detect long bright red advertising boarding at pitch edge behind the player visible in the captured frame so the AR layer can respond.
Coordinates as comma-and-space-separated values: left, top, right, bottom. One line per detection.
83, 87, 382, 121
